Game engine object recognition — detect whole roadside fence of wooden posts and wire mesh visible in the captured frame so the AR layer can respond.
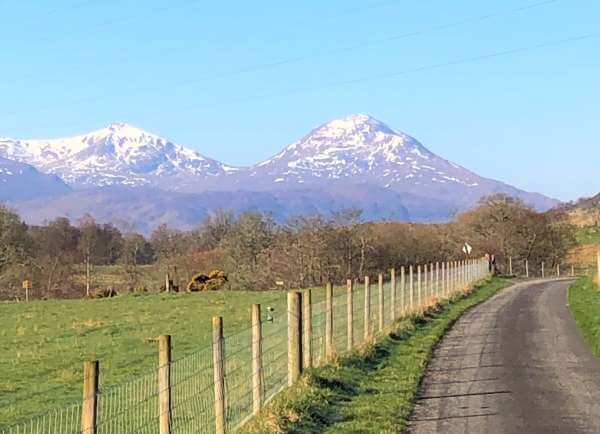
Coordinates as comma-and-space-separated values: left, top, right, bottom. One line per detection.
0, 259, 489, 434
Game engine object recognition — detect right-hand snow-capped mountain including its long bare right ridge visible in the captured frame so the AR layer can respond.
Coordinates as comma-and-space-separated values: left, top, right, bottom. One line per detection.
221, 114, 556, 211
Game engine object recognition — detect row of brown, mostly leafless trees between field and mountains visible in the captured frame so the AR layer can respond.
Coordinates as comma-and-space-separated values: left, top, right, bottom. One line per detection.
0, 195, 574, 296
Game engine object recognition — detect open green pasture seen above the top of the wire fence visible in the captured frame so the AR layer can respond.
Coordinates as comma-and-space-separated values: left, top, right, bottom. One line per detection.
0, 291, 285, 428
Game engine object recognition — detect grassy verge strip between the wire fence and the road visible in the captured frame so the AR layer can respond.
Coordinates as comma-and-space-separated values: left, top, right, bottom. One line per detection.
243, 278, 510, 433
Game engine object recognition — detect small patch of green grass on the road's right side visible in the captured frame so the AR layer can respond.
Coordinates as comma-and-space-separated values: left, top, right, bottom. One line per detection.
569, 277, 600, 357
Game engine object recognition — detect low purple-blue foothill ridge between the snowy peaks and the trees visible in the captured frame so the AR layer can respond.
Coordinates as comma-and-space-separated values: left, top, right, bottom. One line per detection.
15, 186, 408, 234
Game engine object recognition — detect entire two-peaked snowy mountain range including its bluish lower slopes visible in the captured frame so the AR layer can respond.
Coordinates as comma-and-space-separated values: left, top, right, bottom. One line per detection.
0, 115, 558, 230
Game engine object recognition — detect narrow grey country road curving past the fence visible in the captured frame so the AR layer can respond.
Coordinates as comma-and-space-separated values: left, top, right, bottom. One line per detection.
409, 280, 600, 434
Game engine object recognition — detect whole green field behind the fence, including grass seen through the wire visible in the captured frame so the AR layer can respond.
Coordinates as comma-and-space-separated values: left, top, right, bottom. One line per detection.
0, 266, 482, 434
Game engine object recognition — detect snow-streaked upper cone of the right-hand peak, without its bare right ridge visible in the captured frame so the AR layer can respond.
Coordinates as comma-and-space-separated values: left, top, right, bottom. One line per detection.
239, 114, 479, 190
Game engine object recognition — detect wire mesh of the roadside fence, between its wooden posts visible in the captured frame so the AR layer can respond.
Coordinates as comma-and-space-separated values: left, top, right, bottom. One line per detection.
0, 260, 490, 434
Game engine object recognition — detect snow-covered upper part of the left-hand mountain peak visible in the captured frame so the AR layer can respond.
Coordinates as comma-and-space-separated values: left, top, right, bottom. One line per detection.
0, 123, 233, 188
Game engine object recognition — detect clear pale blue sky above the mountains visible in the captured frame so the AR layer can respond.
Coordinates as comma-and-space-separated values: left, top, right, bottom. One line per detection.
0, 0, 600, 200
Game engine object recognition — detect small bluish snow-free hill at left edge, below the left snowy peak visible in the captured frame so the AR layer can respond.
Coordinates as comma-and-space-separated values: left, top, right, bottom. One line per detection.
0, 157, 71, 202
